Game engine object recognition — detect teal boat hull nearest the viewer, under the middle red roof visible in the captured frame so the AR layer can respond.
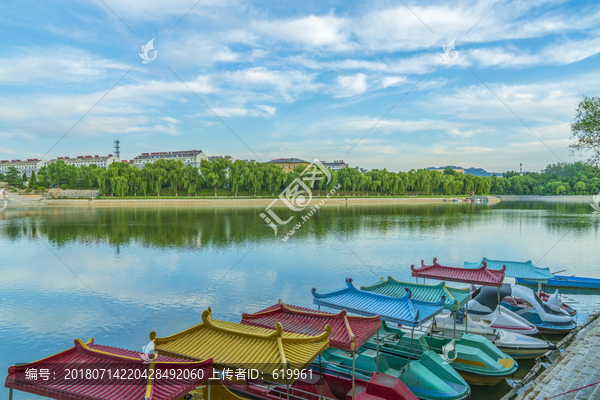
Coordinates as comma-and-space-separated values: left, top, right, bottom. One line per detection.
321, 348, 471, 400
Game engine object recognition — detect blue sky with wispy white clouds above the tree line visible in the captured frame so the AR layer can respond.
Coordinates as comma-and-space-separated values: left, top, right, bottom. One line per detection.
0, 0, 600, 172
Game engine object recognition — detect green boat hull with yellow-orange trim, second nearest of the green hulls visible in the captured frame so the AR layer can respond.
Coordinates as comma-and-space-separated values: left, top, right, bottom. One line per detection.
363, 322, 519, 386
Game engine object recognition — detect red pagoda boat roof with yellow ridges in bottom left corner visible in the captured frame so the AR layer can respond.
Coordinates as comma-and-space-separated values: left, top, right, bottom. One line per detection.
4, 339, 213, 400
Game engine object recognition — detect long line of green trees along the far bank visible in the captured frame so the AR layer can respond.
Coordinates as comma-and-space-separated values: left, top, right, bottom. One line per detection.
0, 159, 600, 197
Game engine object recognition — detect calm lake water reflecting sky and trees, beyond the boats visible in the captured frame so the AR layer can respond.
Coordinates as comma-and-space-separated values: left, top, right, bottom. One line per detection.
0, 202, 600, 399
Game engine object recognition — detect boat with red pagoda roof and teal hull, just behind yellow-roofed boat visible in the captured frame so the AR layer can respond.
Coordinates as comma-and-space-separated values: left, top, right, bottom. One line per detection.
241, 300, 471, 400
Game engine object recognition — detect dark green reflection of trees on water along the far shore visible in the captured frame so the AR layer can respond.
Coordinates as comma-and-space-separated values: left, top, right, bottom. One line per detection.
0, 202, 600, 250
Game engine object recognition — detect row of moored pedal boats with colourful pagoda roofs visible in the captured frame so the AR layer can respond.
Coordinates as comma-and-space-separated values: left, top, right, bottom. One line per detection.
5, 259, 574, 400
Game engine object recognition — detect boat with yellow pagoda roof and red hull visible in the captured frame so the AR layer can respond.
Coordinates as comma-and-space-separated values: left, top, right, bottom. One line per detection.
150, 308, 416, 400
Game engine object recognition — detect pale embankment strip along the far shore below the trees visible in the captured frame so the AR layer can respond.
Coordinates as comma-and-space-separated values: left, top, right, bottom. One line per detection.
40, 196, 500, 208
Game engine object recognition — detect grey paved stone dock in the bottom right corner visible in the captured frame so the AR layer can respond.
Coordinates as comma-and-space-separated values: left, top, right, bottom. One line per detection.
516, 319, 600, 400
